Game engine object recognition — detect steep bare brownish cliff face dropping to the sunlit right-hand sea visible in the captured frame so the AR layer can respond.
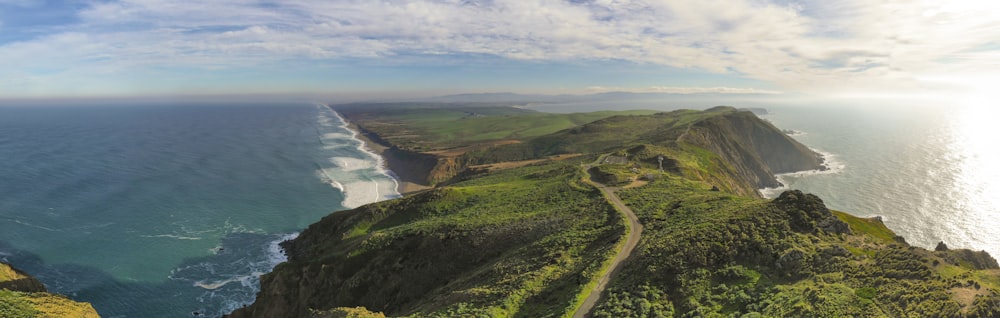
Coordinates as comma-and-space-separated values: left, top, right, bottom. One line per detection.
678, 111, 825, 188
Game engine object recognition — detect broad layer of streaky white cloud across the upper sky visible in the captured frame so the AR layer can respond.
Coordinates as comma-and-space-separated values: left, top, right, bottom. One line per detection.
0, 0, 1000, 95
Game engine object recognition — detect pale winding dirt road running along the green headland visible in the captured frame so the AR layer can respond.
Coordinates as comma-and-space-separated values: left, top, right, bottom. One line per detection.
573, 156, 642, 318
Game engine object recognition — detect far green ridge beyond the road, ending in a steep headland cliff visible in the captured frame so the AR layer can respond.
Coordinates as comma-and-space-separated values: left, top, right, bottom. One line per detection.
464, 106, 825, 197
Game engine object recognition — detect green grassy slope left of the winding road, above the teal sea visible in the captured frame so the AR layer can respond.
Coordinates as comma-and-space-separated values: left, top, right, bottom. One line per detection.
236, 159, 624, 317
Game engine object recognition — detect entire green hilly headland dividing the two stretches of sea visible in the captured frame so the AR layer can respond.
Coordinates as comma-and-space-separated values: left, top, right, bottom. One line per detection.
231, 105, 1000, 317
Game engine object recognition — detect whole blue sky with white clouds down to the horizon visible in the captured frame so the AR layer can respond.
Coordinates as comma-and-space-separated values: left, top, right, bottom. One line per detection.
0, 0, 1000, 99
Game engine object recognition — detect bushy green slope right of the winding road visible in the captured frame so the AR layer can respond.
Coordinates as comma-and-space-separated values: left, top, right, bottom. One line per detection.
595, 177, 1000, 317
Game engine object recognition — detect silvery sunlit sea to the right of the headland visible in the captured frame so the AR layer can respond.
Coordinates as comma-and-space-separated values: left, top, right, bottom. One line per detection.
528, 100, 1000, 258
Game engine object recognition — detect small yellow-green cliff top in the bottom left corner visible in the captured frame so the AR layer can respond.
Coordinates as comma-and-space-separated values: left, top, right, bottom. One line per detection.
0, 263, 100, 318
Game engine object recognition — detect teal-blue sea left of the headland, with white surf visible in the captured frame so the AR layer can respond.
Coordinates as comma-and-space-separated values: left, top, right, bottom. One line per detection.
0, 103, 399, 317
